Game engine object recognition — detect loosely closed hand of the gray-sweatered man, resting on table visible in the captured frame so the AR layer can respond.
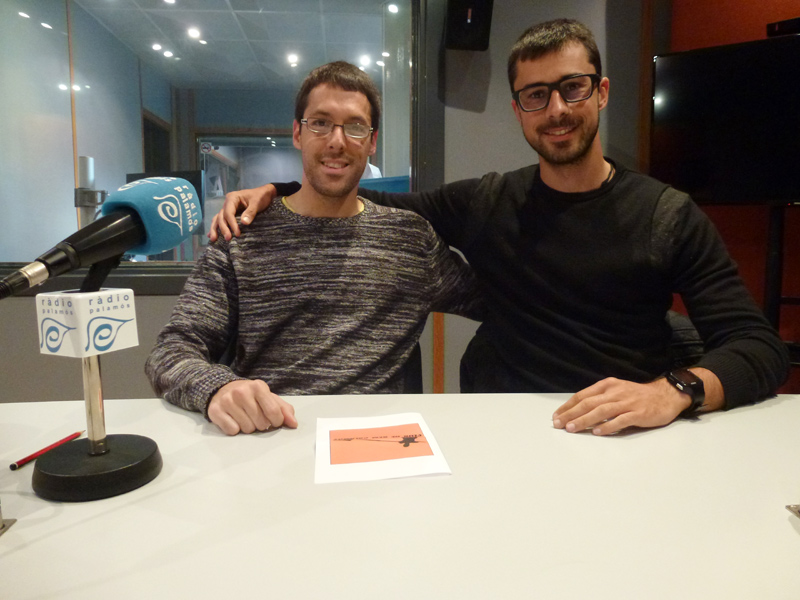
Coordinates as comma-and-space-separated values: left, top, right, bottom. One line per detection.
208, 380, 297, 435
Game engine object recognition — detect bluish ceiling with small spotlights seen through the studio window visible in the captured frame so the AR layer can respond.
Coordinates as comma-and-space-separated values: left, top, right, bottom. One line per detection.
73, 0, 392, 89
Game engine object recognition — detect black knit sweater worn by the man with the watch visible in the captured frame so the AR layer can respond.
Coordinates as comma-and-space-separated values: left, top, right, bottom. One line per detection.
360, 165, 788, 408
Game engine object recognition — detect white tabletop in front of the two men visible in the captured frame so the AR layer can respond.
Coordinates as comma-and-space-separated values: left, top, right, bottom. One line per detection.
0, 394, 800, 600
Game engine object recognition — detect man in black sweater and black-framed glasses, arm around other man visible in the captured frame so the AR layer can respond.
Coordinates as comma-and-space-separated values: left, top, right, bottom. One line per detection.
206, 19, 788, 435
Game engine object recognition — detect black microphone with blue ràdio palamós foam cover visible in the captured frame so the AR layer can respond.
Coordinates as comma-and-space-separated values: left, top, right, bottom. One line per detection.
0, 177, 202, 300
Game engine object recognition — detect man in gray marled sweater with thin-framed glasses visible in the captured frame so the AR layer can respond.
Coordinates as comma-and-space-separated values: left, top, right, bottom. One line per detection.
145, 62, 482, 435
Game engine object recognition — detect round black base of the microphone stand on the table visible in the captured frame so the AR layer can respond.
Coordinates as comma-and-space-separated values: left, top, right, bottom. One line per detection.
32, 435, 163, 502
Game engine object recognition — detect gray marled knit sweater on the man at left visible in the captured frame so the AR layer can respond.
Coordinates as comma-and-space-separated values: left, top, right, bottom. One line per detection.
145, 200, 483, 413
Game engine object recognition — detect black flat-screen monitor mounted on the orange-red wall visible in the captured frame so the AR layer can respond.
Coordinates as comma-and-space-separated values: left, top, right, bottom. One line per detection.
650, 35, 800, 205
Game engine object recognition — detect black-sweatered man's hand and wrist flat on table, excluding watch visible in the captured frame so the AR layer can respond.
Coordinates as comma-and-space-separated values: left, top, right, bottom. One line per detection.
553, 369, 723, 435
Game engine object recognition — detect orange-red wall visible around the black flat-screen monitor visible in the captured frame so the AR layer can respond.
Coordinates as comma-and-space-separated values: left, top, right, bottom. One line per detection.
670, 0, 800, 393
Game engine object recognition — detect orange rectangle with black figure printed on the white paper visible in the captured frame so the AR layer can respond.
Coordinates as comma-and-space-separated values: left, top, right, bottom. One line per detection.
330, 423, 433, 465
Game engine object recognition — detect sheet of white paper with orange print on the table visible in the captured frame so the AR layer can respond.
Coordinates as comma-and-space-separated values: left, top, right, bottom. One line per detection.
314, 413, 450, 483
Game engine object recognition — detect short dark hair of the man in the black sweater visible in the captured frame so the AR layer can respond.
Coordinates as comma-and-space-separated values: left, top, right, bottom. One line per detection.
508, 19, 603, 94
